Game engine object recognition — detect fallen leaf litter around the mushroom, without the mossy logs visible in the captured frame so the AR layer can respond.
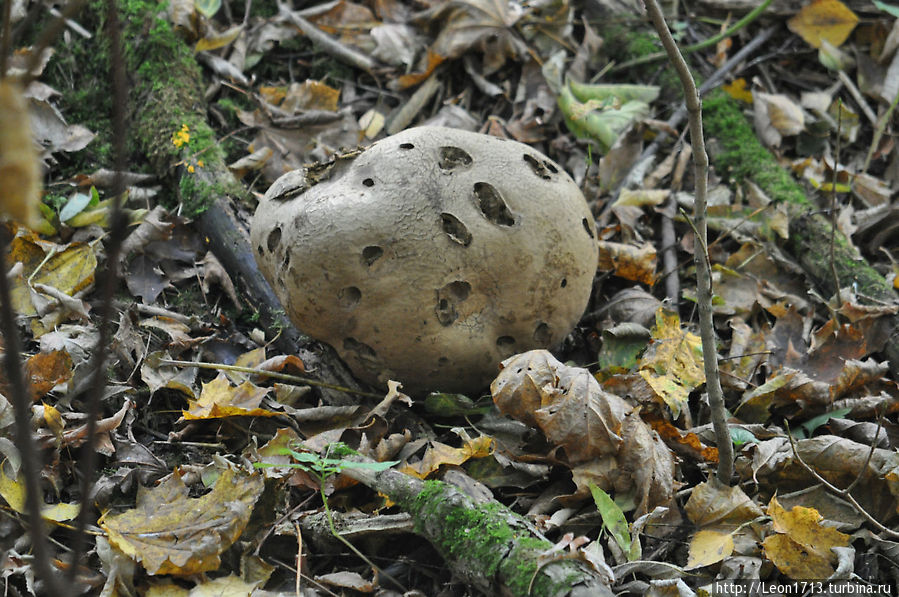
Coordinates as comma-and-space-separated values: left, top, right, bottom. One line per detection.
0, 0, 899, 595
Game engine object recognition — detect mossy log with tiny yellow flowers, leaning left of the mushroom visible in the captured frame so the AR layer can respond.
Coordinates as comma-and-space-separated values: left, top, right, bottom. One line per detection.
111, 1, 357, 404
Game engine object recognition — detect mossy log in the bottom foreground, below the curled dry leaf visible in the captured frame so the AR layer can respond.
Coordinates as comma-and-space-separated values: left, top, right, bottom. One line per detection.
345, 468, 613, 597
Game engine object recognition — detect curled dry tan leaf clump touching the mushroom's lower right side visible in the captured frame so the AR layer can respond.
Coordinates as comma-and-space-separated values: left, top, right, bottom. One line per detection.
490, 350, 674, 515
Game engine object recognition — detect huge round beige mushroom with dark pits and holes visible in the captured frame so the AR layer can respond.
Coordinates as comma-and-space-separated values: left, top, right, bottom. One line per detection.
252, 127, 597, 392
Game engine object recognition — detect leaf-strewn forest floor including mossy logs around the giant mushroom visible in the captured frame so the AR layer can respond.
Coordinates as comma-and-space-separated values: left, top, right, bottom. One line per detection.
0, 0, 899, 596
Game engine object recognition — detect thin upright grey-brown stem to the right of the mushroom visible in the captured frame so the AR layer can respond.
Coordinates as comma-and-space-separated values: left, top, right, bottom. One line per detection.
646, 0, 734, 486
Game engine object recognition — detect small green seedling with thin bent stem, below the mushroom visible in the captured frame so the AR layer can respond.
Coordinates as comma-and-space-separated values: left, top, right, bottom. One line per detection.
253, 442, 402, 586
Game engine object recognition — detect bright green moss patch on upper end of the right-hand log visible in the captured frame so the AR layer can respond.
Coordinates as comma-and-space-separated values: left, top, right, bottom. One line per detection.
702, 91, 810, 206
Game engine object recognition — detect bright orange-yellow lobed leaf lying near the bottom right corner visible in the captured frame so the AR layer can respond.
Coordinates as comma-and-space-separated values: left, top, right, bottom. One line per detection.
763, 497, 850, 579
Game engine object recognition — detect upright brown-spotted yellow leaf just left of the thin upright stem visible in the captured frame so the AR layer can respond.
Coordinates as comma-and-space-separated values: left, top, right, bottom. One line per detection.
639, 307, 705, 417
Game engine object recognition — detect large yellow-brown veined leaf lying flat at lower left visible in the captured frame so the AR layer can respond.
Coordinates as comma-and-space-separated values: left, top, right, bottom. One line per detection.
99, 468, 264, 576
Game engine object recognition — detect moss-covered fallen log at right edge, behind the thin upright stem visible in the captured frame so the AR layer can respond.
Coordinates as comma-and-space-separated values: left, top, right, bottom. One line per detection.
703, 91, 899, 373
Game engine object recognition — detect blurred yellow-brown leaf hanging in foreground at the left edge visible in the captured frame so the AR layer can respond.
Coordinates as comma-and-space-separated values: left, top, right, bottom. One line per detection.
0, 78, 42, 228
